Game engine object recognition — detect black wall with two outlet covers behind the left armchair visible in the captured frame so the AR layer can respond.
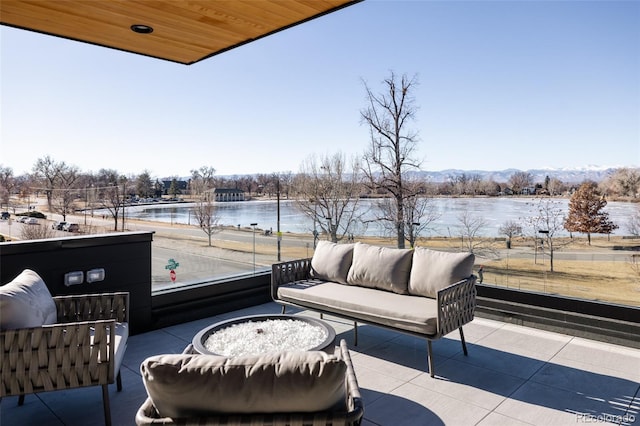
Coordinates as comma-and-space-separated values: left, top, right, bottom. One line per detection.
0, 232, 153, 333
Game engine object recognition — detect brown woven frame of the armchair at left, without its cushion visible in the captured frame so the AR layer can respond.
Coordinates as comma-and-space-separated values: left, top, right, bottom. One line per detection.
0, 292, 129, 425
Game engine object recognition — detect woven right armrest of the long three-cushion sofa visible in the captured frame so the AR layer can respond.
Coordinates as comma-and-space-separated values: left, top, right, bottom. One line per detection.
437, 275, 477, 337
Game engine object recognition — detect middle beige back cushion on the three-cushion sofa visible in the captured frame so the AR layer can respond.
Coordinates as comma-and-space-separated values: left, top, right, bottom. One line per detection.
347, 243, 412, 294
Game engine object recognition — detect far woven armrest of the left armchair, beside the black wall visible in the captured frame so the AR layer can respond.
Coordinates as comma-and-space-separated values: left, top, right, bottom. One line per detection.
53, 292, 129, 323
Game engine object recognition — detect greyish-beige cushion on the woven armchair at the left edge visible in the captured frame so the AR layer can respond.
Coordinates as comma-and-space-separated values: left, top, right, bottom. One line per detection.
0, 269, 58, 330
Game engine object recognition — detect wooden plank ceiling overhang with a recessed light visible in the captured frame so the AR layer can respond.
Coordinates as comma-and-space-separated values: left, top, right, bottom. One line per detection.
0, 0, 362, 64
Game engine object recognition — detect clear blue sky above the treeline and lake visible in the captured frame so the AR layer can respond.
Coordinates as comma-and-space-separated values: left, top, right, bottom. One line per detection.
0, 0, 640, 177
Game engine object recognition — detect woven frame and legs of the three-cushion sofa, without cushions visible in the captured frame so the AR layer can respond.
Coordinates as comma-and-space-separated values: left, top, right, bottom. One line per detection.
271, 258, 477, 377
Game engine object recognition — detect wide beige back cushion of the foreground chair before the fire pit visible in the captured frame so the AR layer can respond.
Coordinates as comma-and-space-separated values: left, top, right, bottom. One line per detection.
140, 351, 346, 418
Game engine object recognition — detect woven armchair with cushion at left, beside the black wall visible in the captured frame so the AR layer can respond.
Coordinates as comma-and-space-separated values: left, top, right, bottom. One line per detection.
0, 269, 129, 425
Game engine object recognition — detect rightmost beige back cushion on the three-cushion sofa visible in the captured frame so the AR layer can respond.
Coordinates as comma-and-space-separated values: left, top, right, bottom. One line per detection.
409, 247, 475, 298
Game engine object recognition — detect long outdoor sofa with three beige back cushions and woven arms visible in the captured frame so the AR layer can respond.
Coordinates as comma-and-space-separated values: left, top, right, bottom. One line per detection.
271, 241, 476, 377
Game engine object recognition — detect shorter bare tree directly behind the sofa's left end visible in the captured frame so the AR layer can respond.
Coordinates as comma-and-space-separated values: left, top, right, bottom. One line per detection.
296, 153, 361, 243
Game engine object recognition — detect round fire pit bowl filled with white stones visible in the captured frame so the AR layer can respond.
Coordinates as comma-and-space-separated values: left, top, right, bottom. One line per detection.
192, 315, 336, 356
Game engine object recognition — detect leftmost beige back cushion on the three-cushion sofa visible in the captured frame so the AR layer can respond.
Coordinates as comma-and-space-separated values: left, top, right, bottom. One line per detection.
311, 241, 353, 284
